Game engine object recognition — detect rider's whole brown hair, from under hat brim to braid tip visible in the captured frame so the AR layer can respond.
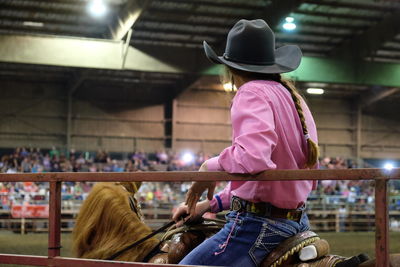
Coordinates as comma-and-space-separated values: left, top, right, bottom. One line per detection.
224, 67, 319, 168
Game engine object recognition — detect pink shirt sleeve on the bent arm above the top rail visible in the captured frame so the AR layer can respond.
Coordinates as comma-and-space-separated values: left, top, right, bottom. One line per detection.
218, 88, 278, 174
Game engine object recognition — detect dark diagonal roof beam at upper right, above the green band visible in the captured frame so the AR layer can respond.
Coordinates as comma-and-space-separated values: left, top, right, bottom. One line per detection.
331, 10, 400, 58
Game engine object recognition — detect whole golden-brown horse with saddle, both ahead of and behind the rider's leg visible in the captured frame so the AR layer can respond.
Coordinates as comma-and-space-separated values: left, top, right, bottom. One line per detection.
73, 183, 400, 267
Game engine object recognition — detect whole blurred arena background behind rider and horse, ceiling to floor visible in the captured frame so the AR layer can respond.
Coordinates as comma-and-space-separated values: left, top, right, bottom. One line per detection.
0, 0, 400, 260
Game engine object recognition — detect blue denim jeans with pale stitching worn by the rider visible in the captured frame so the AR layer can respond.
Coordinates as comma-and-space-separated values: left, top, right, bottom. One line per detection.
179, 211, 310, 267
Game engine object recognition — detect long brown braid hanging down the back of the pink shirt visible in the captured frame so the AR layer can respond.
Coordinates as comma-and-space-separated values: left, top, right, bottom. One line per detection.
279, 75, 319, 168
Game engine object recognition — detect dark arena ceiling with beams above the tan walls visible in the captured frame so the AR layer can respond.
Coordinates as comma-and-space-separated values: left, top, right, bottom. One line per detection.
0, 0, 400, 110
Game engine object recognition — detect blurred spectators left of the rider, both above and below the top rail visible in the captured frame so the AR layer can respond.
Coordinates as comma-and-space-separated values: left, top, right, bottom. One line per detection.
0, 147, 216, 209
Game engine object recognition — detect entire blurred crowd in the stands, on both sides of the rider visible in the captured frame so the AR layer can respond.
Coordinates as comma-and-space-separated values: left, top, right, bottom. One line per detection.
0, 147, 400, 213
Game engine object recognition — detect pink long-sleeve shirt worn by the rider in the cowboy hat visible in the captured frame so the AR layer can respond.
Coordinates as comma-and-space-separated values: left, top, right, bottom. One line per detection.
206, 80, 318, 212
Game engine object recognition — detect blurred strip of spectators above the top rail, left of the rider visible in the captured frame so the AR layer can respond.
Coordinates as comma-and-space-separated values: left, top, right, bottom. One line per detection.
0, 147, 208, 173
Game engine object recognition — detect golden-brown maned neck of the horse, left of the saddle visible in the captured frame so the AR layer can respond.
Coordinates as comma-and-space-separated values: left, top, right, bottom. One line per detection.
73, 183, 159, 261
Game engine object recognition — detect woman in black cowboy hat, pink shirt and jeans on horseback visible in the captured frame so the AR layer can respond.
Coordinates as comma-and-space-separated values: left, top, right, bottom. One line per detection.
173, 19, 318, 267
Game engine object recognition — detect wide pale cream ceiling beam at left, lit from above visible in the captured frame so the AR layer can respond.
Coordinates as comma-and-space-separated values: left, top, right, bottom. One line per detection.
0, 35, 182, 73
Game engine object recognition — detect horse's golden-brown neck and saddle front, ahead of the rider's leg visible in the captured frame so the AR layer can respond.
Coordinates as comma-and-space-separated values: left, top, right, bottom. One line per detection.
73, 183, 219, 263
